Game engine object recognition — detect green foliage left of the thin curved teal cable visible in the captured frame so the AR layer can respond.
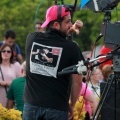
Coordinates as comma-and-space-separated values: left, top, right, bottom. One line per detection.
0, 0, 47, 56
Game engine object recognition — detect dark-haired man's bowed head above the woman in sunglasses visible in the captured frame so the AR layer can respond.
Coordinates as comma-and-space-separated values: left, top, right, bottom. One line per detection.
4, 30, 16, 46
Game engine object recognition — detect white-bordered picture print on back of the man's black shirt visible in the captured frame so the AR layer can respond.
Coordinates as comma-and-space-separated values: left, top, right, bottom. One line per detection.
30, 42, 62, 78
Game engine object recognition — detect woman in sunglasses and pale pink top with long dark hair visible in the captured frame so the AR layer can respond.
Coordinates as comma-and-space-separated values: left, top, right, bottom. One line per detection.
0, 44, 21, 107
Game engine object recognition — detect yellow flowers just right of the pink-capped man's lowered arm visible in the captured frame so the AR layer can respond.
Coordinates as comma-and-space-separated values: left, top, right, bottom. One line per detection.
73, 96, 86, 120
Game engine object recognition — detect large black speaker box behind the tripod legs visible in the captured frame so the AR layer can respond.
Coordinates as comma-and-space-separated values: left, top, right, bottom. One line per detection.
100, 81, 120, 120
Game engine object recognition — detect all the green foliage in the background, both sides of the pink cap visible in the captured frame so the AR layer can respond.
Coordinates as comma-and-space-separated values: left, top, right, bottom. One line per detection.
0, 0, 120, 56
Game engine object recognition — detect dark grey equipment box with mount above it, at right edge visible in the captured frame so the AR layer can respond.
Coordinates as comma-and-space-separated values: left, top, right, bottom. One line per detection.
101, 11, 120, 49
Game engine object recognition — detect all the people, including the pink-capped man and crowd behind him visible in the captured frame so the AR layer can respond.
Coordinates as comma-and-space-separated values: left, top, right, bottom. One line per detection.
0, 5, 113, 120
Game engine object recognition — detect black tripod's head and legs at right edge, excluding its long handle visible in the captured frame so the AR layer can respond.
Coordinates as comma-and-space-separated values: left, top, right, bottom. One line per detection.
92, 47, 120, 120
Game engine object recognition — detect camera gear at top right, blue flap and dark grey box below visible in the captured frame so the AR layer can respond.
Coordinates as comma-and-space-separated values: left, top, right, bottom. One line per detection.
80, 0, 120, 49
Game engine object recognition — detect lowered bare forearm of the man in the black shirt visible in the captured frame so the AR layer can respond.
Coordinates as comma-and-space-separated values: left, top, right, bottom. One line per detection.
69, 74, 82, 119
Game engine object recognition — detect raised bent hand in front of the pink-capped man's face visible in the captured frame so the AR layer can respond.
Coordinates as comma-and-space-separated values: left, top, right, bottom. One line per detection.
68, 20, 83, 35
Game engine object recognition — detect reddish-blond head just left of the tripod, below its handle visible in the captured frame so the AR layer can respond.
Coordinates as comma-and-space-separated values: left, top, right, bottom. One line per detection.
102, 64, 113, 80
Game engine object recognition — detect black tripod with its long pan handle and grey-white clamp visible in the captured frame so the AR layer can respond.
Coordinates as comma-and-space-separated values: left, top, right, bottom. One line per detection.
58, 47, 120, 120
